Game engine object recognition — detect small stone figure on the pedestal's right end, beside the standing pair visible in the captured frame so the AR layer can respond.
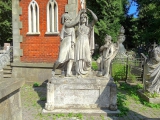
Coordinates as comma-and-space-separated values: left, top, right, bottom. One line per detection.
97, 35, 118, 79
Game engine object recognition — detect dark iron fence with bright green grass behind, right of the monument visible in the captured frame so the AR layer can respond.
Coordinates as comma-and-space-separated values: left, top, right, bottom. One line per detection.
111, 56, 144, 81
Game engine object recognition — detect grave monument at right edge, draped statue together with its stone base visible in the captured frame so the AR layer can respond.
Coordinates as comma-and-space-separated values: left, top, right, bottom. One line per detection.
138, 44, 160, 103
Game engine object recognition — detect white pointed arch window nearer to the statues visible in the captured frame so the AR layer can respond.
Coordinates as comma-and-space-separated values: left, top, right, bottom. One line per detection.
46, 0, 59, 34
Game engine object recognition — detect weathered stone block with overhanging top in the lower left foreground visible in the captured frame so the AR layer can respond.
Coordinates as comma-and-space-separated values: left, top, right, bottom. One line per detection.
0, 79, 24, 120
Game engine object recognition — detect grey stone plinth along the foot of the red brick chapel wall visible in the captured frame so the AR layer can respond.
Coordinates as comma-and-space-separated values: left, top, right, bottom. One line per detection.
11, 63, 54, 83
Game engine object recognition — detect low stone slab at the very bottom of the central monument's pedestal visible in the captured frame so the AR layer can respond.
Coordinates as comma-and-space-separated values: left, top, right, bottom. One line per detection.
42, 109, 120, 116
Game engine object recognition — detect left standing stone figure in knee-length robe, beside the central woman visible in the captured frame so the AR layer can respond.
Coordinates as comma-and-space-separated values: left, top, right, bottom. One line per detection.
52, 13, 75, 77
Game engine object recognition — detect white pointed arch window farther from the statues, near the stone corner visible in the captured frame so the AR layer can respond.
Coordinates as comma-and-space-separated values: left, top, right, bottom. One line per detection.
27, 0, 40, 34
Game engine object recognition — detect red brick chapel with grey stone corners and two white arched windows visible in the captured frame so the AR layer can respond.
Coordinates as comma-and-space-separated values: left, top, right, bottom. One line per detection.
11, 0, 82, 81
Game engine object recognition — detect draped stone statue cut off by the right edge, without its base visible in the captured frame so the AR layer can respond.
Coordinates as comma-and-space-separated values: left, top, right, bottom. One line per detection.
146, 46, 160, 94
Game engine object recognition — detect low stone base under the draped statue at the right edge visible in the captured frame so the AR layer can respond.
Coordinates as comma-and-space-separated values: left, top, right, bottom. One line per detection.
138, 89, 160, 104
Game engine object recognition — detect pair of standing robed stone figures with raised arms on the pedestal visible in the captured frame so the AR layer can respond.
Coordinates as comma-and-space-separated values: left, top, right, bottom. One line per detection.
52, 9, 98, 77
